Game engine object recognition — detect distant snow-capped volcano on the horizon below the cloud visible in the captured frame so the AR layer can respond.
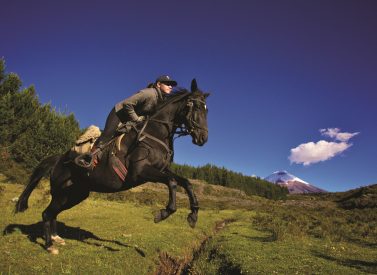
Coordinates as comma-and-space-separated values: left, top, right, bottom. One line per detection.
265, 171, 326, 194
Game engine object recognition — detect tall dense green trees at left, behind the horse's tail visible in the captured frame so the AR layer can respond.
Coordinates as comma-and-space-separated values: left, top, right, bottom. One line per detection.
0, 59, 80, 182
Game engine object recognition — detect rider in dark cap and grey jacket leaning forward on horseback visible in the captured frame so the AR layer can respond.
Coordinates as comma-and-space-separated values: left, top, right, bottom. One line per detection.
78, 75, 177, 168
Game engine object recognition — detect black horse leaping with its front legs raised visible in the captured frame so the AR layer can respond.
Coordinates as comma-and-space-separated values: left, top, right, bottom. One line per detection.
15, 79, 209, 254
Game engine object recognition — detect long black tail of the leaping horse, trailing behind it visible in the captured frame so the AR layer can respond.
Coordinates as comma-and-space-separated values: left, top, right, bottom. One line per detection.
15, 155, 61, 213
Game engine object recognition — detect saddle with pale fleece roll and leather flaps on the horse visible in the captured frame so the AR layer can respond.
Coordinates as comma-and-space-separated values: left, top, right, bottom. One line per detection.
71, 125, 128, 181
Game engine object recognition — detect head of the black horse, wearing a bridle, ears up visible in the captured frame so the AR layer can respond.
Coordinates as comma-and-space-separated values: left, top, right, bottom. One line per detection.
184, 79, 209, 146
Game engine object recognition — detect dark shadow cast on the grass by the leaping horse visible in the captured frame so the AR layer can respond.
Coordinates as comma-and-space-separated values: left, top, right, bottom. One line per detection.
3, 222, 145, 257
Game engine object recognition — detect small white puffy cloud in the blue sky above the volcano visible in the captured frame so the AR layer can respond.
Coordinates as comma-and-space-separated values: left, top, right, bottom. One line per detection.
288, 128, 359, 166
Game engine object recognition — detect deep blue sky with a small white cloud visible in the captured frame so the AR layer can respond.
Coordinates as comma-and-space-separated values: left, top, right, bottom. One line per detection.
0, 0, 377, 191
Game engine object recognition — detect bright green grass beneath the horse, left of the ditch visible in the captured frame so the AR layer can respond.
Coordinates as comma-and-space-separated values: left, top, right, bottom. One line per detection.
0, 179, 241, 274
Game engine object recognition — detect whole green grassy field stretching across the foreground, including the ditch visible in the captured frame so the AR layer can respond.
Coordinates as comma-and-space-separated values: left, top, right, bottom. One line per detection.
0, 177, 377, 274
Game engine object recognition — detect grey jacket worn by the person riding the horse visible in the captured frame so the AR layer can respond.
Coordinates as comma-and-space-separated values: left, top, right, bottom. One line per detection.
115, 88, 163, 123
